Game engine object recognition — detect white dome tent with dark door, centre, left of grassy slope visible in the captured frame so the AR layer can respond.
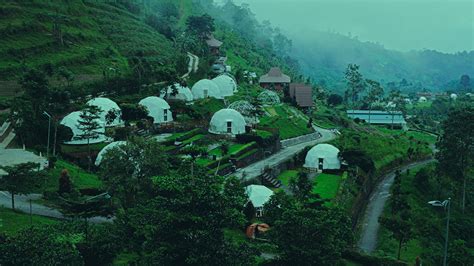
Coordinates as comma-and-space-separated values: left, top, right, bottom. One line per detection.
209, 109, 246, 135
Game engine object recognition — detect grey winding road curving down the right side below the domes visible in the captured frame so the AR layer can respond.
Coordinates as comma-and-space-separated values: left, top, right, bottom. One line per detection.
358, 159, 435, 254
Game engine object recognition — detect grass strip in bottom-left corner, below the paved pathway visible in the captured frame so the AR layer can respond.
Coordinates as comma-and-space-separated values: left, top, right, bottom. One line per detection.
0, 207, 58, 234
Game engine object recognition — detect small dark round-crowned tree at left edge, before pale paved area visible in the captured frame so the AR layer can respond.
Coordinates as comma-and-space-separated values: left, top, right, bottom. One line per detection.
0, 163, 40, 209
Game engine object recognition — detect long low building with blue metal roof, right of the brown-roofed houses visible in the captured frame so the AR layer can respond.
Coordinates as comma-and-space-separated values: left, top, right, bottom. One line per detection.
347, 110, 407, 126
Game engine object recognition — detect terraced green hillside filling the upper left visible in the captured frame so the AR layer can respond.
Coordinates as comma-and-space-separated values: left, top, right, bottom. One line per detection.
0, 1, 185, 93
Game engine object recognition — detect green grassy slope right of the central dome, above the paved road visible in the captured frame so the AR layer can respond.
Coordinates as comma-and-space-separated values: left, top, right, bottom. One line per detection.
260, 105, 313, 139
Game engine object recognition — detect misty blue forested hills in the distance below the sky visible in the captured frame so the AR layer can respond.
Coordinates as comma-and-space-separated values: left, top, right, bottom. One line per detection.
291, 31, 474, 91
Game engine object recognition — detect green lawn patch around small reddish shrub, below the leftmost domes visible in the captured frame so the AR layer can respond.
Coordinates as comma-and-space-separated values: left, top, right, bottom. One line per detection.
42, 160, 102, 190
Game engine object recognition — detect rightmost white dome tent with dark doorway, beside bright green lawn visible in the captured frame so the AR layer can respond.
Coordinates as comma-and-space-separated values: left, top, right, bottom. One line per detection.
304, 144, 341, 170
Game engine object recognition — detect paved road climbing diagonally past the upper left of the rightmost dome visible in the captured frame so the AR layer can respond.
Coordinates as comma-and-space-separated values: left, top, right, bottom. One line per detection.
234, 127, 336, 180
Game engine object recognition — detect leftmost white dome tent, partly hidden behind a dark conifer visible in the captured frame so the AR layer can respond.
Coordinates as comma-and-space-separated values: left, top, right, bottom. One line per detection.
61, 111, 106, 145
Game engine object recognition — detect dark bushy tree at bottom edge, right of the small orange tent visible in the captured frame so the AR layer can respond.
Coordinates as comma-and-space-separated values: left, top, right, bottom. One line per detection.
270, 208, 353, 265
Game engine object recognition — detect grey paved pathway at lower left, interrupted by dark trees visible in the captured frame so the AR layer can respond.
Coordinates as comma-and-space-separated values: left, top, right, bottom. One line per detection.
0, 191, 113, 223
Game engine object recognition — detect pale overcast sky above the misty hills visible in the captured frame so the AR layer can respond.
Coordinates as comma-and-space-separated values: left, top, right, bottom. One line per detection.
234, 0, 474, 53
